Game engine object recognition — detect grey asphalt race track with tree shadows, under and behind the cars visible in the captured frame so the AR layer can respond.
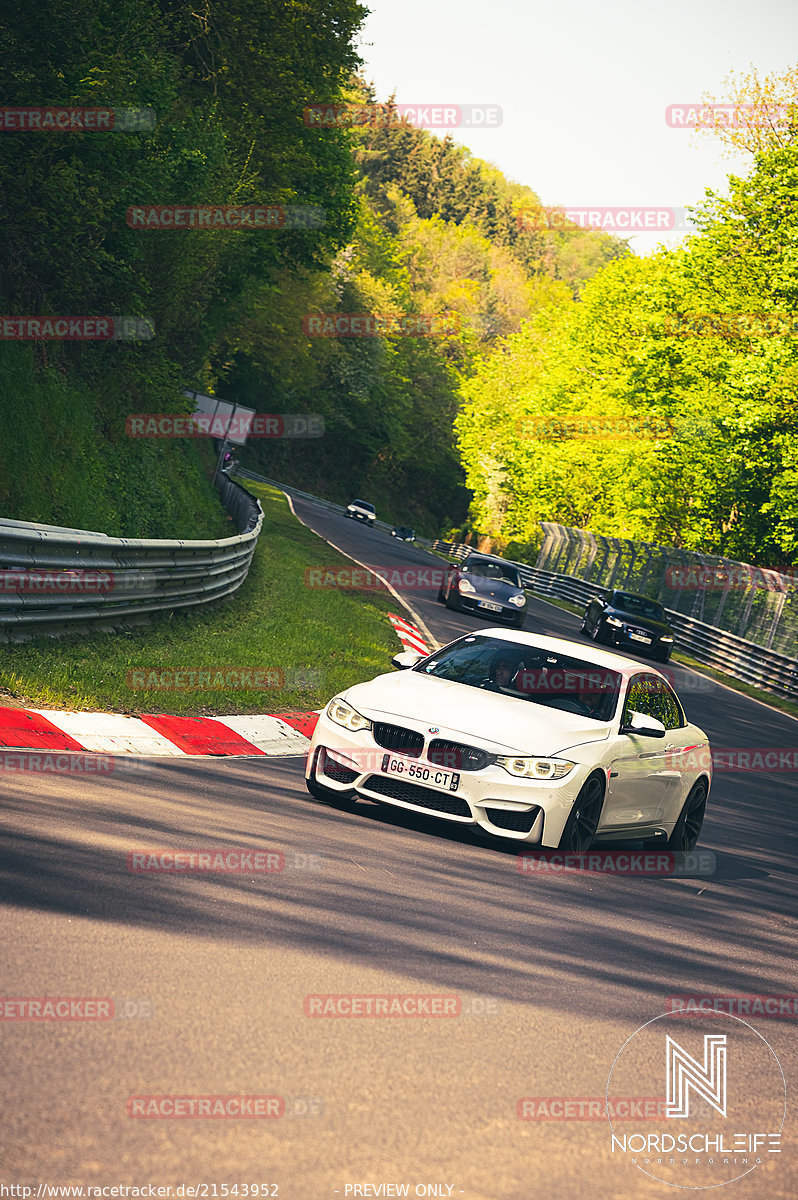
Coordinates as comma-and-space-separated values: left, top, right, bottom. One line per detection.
0, 492, 798, 1200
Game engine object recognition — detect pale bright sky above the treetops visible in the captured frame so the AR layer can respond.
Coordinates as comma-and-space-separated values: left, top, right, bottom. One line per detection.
359, 0, 798, 253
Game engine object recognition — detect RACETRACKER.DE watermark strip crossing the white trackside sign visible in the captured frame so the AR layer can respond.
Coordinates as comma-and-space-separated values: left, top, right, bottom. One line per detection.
125, 413, 324, 442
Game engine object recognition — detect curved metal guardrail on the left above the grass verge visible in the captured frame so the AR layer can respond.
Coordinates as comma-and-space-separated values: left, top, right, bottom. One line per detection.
0, 475, 263, 642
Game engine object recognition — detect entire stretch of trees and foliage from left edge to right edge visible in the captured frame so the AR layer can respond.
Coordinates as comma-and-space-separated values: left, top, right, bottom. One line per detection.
7, 0, 798, 563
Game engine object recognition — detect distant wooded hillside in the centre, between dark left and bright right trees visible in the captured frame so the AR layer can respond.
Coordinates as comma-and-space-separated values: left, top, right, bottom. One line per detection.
212, 84, 628, 534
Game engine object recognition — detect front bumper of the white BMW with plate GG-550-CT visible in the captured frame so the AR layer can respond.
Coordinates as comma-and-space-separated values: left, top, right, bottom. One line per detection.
305, 713, 594, 847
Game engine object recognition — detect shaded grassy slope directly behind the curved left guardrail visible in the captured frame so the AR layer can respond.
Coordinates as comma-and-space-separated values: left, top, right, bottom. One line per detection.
0, 342, 230, 539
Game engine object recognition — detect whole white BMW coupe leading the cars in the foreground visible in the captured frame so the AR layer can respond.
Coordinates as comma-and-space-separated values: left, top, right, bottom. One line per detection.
306, 629, 712, 853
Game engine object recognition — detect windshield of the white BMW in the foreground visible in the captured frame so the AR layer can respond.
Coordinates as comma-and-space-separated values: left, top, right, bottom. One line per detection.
414, 634, 622, 721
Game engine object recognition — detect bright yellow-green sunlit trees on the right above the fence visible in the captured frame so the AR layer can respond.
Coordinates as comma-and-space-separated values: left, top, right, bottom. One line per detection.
458, 142, 798, 565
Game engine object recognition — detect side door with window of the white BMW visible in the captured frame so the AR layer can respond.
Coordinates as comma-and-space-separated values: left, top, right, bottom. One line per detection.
601, 671, 685, 832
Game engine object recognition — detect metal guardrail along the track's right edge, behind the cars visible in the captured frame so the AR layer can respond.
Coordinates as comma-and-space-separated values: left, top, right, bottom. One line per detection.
432, 541, 798, 701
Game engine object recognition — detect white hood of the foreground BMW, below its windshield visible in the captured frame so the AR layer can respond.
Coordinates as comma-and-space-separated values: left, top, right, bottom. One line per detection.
344, 671, 610, 756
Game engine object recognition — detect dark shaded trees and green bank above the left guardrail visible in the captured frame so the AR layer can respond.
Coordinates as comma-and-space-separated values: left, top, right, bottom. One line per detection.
0, 0, 365, 536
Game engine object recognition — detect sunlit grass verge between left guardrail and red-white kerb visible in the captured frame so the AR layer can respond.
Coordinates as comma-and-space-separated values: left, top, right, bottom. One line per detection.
0, 484, 401, 716
